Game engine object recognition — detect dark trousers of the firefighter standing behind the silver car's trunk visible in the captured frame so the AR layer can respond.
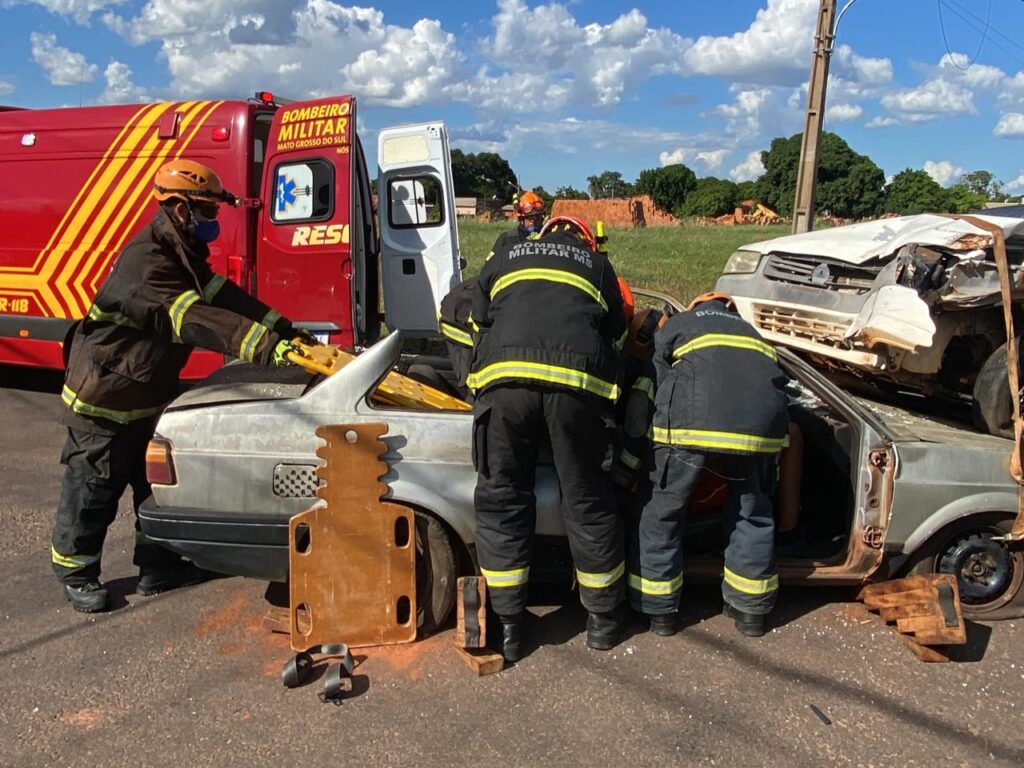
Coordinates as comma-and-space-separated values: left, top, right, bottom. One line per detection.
50, 418, 179, 586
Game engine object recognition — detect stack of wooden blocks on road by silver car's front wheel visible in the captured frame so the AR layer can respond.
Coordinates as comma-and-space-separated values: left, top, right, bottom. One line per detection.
858, 573, 967, 662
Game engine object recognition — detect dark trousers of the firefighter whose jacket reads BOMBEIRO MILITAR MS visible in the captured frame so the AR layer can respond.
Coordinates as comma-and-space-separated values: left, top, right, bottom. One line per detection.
473, 385, 626, 616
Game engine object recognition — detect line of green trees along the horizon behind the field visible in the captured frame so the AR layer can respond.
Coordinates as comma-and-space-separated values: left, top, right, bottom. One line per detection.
452, 131, 1007, 219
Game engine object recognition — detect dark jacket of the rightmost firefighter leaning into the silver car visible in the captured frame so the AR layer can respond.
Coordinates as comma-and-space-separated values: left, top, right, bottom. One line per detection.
653, 301, 790, 454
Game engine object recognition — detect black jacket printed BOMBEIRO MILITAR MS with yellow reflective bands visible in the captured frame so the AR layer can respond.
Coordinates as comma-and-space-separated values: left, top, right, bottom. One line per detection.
469, 232, 627, 402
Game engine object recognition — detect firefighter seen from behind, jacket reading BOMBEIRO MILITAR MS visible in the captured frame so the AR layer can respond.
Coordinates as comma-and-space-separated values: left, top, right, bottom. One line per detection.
469, 218, 626, 660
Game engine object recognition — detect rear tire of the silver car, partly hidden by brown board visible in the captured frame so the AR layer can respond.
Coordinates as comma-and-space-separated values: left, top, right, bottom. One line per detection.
416, 510, 457, 637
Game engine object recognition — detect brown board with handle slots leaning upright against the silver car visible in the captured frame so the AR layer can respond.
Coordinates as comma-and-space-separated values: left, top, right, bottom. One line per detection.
288, 424, 416, 651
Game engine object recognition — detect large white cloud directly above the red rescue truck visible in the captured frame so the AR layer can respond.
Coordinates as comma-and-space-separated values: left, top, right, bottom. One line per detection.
104, 0, 465, 106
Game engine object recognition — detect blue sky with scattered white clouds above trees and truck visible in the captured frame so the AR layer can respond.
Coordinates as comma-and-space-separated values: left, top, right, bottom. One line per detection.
0, 0, 1024, 193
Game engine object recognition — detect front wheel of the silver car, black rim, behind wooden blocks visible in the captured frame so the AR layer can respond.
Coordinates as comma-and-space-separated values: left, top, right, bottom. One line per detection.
903, 513, 1024, 622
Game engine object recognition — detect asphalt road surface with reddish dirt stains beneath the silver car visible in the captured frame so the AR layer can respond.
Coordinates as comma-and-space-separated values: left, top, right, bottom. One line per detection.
0, 370, 1024, 768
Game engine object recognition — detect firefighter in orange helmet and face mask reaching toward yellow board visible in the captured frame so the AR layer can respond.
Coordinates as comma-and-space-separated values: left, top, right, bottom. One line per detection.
51, 160, 296, 612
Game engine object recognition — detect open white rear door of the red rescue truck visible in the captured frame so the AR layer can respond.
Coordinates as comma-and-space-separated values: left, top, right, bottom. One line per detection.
377, 123, 462, 336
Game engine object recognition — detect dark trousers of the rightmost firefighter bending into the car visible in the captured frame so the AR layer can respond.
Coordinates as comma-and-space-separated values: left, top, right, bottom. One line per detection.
629, 444, 778, 615
